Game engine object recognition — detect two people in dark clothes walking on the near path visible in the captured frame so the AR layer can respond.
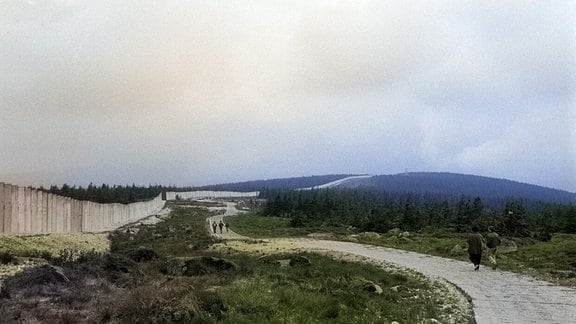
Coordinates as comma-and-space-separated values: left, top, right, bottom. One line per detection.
468, 226, 502, 271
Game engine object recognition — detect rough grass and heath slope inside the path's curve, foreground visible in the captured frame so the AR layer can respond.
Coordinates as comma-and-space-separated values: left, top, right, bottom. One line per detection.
0, 201, 472, 323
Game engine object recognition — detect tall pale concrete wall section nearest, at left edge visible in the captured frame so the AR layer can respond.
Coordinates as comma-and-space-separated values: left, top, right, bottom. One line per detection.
0, 182, 166, 234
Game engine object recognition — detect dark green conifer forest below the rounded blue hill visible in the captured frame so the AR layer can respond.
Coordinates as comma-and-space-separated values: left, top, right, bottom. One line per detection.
261, 189, 576, 239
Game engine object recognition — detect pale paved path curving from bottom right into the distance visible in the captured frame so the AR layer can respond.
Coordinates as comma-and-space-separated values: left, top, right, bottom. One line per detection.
207, 203, 576, 324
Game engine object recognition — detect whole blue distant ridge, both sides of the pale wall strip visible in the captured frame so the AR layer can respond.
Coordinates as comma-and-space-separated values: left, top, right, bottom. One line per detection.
205, 172, 576, 204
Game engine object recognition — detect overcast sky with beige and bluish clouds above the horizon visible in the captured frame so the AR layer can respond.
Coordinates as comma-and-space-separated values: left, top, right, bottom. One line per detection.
0, 0, 576, 192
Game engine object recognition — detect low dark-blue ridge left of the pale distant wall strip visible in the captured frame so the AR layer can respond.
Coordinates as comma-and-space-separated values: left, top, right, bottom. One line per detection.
194, 174, 353, 192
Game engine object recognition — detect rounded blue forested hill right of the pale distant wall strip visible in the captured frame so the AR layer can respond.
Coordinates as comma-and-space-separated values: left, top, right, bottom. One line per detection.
339, 172, 576, 203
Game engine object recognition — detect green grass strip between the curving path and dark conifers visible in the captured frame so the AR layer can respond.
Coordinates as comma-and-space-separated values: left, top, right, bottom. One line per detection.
230, 214, 576, 287
